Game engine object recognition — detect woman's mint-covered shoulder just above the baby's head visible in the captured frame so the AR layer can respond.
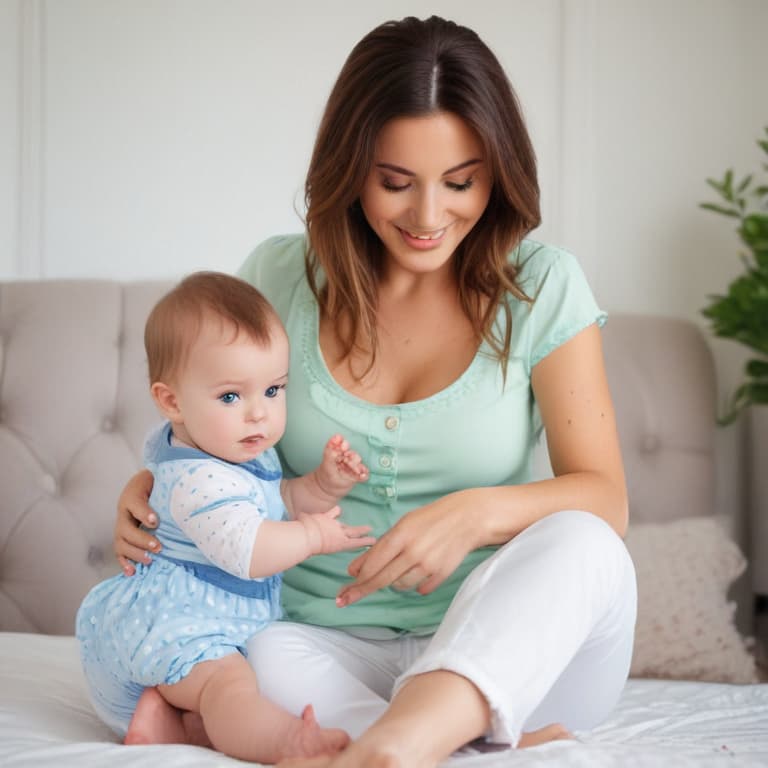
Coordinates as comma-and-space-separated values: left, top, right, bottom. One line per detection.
237, 234, 307, 320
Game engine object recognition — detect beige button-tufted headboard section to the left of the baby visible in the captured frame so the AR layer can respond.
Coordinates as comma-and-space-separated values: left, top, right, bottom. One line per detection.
0, 280, 169, 634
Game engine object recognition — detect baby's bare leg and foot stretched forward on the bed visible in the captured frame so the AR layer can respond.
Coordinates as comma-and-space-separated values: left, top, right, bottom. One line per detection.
158, 653, 349, 763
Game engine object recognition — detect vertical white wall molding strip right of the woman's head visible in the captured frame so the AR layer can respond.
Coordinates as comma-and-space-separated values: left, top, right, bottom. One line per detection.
557, 0, 599, 277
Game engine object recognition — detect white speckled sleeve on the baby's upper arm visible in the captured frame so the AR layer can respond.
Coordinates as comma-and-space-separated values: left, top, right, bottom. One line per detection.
170, 461, 267, 579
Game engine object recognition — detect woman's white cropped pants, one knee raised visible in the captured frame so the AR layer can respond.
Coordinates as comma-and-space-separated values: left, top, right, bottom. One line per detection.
248, 511, 637, 744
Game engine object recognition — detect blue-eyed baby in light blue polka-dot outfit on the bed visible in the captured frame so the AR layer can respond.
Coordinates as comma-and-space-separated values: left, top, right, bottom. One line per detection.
77, 272, 374, 763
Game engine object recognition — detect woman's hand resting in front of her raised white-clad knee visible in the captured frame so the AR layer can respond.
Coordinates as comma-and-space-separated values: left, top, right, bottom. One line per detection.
336, 491, 484, 607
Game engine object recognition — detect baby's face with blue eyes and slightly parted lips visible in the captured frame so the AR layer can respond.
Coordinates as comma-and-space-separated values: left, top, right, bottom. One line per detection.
173, 316, 289, 464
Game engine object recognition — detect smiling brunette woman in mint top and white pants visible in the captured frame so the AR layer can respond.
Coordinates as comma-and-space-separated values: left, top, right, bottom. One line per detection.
116, 17, 636, 766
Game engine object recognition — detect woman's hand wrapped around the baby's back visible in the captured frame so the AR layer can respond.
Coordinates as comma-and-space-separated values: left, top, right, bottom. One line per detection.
113, 469, 160, 576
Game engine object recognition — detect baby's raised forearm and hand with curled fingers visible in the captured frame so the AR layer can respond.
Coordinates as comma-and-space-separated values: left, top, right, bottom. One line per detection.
280, 435, 370, 519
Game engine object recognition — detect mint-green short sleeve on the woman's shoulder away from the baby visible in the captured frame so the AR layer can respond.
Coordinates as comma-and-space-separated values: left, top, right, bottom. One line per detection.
519, 246, 608, 371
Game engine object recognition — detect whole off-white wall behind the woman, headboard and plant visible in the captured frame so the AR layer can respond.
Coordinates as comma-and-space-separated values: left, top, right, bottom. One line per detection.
0, 0, 768, 536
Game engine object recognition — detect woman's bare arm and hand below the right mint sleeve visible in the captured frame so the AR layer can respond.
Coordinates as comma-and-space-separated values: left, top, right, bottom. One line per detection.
337, 325, 628, 606
